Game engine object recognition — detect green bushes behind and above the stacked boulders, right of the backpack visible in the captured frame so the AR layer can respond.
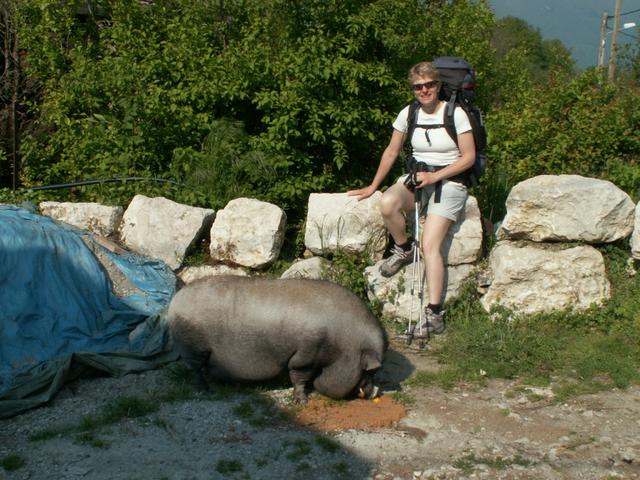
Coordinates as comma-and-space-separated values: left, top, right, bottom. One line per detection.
487, 71, 640, 201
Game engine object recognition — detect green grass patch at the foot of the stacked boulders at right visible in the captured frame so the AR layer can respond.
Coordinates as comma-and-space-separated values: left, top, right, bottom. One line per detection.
406, 245, 640, 399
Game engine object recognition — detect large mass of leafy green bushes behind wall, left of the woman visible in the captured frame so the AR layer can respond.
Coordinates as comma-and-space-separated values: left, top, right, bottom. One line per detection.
13, 0, 493, 214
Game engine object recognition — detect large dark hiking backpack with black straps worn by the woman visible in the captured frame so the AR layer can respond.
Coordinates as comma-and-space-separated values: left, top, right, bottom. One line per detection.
406, 57, 487, 187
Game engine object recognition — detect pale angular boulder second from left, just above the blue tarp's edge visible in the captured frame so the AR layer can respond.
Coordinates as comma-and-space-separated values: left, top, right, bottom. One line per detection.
120, 195, 215, 270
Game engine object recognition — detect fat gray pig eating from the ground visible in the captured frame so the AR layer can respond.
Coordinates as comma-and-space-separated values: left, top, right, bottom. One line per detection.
168, 276, 387, 403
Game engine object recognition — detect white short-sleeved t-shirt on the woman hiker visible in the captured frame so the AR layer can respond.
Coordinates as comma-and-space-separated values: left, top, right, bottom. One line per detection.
393, 102, 471, 167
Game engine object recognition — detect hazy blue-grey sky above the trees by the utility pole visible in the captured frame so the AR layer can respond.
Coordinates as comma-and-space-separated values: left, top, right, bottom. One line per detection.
489, 0, 640, 68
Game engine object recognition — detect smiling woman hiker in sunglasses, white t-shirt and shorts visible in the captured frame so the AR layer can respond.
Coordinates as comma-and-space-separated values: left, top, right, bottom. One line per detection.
347, 62, 475, 334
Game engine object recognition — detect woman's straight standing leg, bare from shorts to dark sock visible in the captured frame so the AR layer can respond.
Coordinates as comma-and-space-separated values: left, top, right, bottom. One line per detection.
422, 214, 453, 305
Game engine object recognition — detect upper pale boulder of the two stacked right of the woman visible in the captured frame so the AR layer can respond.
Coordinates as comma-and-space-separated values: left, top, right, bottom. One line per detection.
500, 175, 634, 243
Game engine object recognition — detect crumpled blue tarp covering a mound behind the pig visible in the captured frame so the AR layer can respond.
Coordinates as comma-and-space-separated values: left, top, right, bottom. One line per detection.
0, 205, 176, 418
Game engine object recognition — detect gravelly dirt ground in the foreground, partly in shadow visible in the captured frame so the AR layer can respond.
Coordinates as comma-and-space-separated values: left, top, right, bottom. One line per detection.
0, 338, 640, 480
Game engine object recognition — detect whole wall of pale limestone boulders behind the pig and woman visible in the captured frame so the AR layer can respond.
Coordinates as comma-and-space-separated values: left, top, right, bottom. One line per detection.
40, 175, 640, 319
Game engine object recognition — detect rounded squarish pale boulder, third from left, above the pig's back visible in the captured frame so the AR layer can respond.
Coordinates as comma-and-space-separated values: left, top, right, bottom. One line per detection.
210, 198, 287, 268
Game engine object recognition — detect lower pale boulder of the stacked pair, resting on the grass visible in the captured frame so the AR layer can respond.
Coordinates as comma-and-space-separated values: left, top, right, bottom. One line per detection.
481, 241, 611, 314
